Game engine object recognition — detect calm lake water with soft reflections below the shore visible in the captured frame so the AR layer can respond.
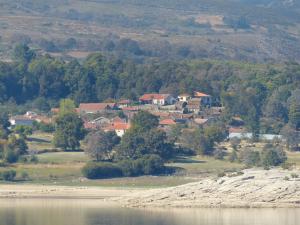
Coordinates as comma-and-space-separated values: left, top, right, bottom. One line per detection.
0, 199, 300, 225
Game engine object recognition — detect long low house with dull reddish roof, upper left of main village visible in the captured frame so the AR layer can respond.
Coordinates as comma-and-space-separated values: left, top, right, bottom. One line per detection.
79, 103, 118, 114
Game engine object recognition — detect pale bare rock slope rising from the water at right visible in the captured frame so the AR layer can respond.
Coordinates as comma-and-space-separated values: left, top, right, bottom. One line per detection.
113, 169, 300, 208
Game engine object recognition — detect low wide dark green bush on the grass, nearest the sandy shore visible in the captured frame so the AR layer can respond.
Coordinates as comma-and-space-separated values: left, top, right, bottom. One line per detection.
82, 162, 123, 179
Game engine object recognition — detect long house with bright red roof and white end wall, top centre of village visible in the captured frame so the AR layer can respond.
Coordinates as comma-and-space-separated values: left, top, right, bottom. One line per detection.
139, 93, 176, 105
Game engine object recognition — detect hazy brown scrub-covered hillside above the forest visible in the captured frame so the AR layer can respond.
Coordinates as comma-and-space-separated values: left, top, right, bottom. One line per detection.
0, 0, 300, 62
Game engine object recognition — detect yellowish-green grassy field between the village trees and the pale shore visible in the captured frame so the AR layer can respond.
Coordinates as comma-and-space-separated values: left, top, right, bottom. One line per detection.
0, 133, 300, 188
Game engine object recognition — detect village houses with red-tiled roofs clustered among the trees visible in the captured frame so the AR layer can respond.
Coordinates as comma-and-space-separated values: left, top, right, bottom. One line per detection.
10, 92, 227, 137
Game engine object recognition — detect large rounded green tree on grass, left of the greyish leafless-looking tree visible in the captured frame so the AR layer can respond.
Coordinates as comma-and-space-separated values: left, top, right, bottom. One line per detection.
53, 113, 85, 151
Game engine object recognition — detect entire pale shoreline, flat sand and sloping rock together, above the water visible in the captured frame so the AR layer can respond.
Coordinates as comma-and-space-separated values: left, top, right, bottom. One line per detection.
0, 169, 300, 208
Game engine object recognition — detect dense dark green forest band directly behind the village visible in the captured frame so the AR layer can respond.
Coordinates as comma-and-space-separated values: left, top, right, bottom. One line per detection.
0, 45, 300, 136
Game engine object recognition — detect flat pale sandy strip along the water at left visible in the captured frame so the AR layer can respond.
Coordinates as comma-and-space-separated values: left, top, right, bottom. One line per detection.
0, 185, 140, 199
